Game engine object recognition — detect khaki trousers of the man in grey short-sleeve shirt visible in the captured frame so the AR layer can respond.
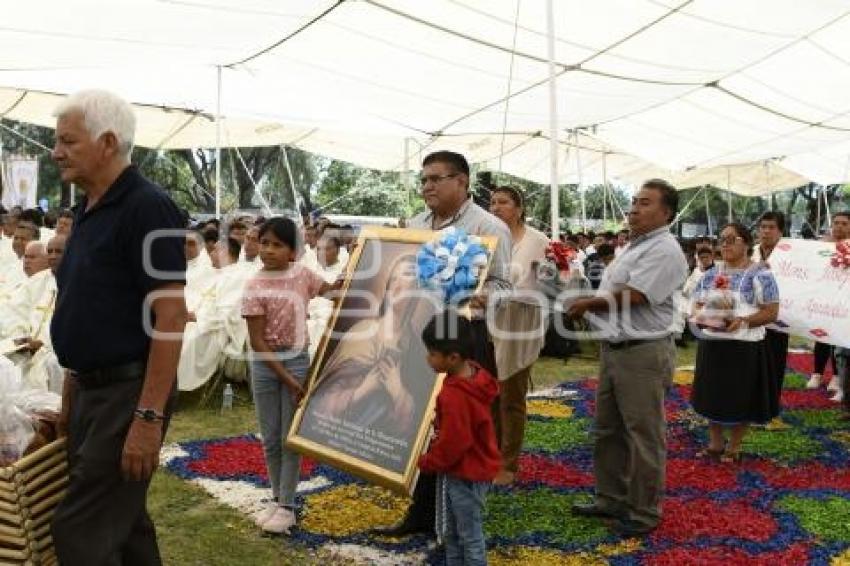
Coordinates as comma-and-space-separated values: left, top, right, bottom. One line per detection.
593, 339, 676, 526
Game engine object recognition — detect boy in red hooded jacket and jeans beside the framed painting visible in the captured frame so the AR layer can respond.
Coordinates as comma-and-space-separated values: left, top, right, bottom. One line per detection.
419, 310, 502, 566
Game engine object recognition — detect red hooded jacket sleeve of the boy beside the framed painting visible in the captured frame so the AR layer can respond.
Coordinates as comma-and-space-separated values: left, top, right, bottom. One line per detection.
419, 394, 473, 473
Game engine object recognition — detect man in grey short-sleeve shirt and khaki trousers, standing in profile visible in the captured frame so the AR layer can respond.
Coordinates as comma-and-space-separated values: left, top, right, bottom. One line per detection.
568, 179, 688, 537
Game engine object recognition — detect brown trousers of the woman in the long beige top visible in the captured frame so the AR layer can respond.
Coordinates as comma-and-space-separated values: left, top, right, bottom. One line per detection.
493, 367, 531, 473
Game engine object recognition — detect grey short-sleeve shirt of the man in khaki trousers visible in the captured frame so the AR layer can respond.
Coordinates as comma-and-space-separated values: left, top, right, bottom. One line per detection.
588, 226, 688, 342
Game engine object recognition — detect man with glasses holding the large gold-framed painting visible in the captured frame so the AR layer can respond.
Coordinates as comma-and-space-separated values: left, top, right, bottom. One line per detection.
373, 151, 511, 536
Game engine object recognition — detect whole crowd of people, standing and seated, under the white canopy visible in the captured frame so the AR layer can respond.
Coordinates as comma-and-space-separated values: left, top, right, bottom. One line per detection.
0, 91, 850, 564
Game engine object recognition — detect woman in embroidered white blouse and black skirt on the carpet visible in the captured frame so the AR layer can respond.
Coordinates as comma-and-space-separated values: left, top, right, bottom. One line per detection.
691, 222, 779, 462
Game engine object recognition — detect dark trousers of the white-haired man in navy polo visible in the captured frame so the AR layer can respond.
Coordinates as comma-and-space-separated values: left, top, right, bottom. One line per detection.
53, 370, 176, 566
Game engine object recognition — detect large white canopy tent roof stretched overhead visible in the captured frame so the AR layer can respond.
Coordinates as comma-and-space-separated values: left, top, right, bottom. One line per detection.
0, 0, 850, 205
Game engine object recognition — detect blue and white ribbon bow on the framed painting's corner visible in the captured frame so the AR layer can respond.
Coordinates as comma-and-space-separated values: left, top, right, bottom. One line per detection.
416, 226, 489, 303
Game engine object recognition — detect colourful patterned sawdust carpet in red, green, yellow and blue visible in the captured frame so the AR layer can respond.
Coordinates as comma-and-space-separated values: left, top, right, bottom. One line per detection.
164, 354, 850, 566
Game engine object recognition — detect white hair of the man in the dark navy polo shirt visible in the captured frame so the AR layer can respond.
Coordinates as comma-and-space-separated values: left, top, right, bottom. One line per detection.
53, 90, 136, 157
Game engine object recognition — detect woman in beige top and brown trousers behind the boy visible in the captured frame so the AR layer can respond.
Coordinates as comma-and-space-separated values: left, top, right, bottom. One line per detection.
490, 187, 549, 485
